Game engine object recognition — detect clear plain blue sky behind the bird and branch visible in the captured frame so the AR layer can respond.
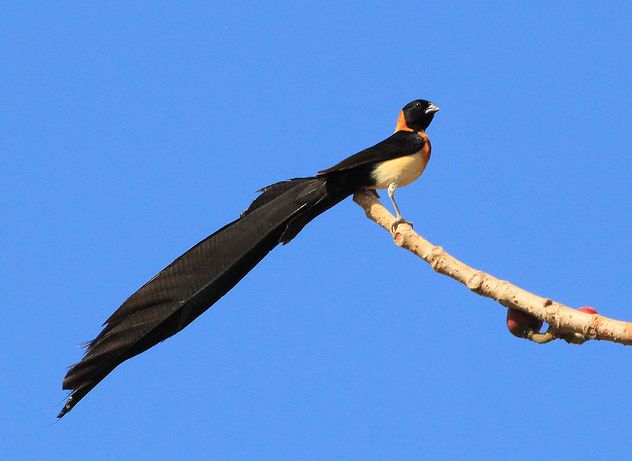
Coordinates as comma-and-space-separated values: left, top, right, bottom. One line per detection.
0, 1, 632, 460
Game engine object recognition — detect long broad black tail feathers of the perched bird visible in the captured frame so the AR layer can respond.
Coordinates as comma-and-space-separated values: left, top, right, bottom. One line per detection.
58, 177, 349, 418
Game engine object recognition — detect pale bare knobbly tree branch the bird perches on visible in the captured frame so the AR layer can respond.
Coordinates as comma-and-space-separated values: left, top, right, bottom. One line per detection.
353, 192, 632, 345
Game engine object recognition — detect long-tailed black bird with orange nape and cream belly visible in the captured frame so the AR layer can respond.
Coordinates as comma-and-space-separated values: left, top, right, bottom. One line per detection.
57, 99, 439, 418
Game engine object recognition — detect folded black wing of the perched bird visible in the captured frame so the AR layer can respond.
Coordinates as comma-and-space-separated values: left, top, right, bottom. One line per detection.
318, 131, 425, 176
